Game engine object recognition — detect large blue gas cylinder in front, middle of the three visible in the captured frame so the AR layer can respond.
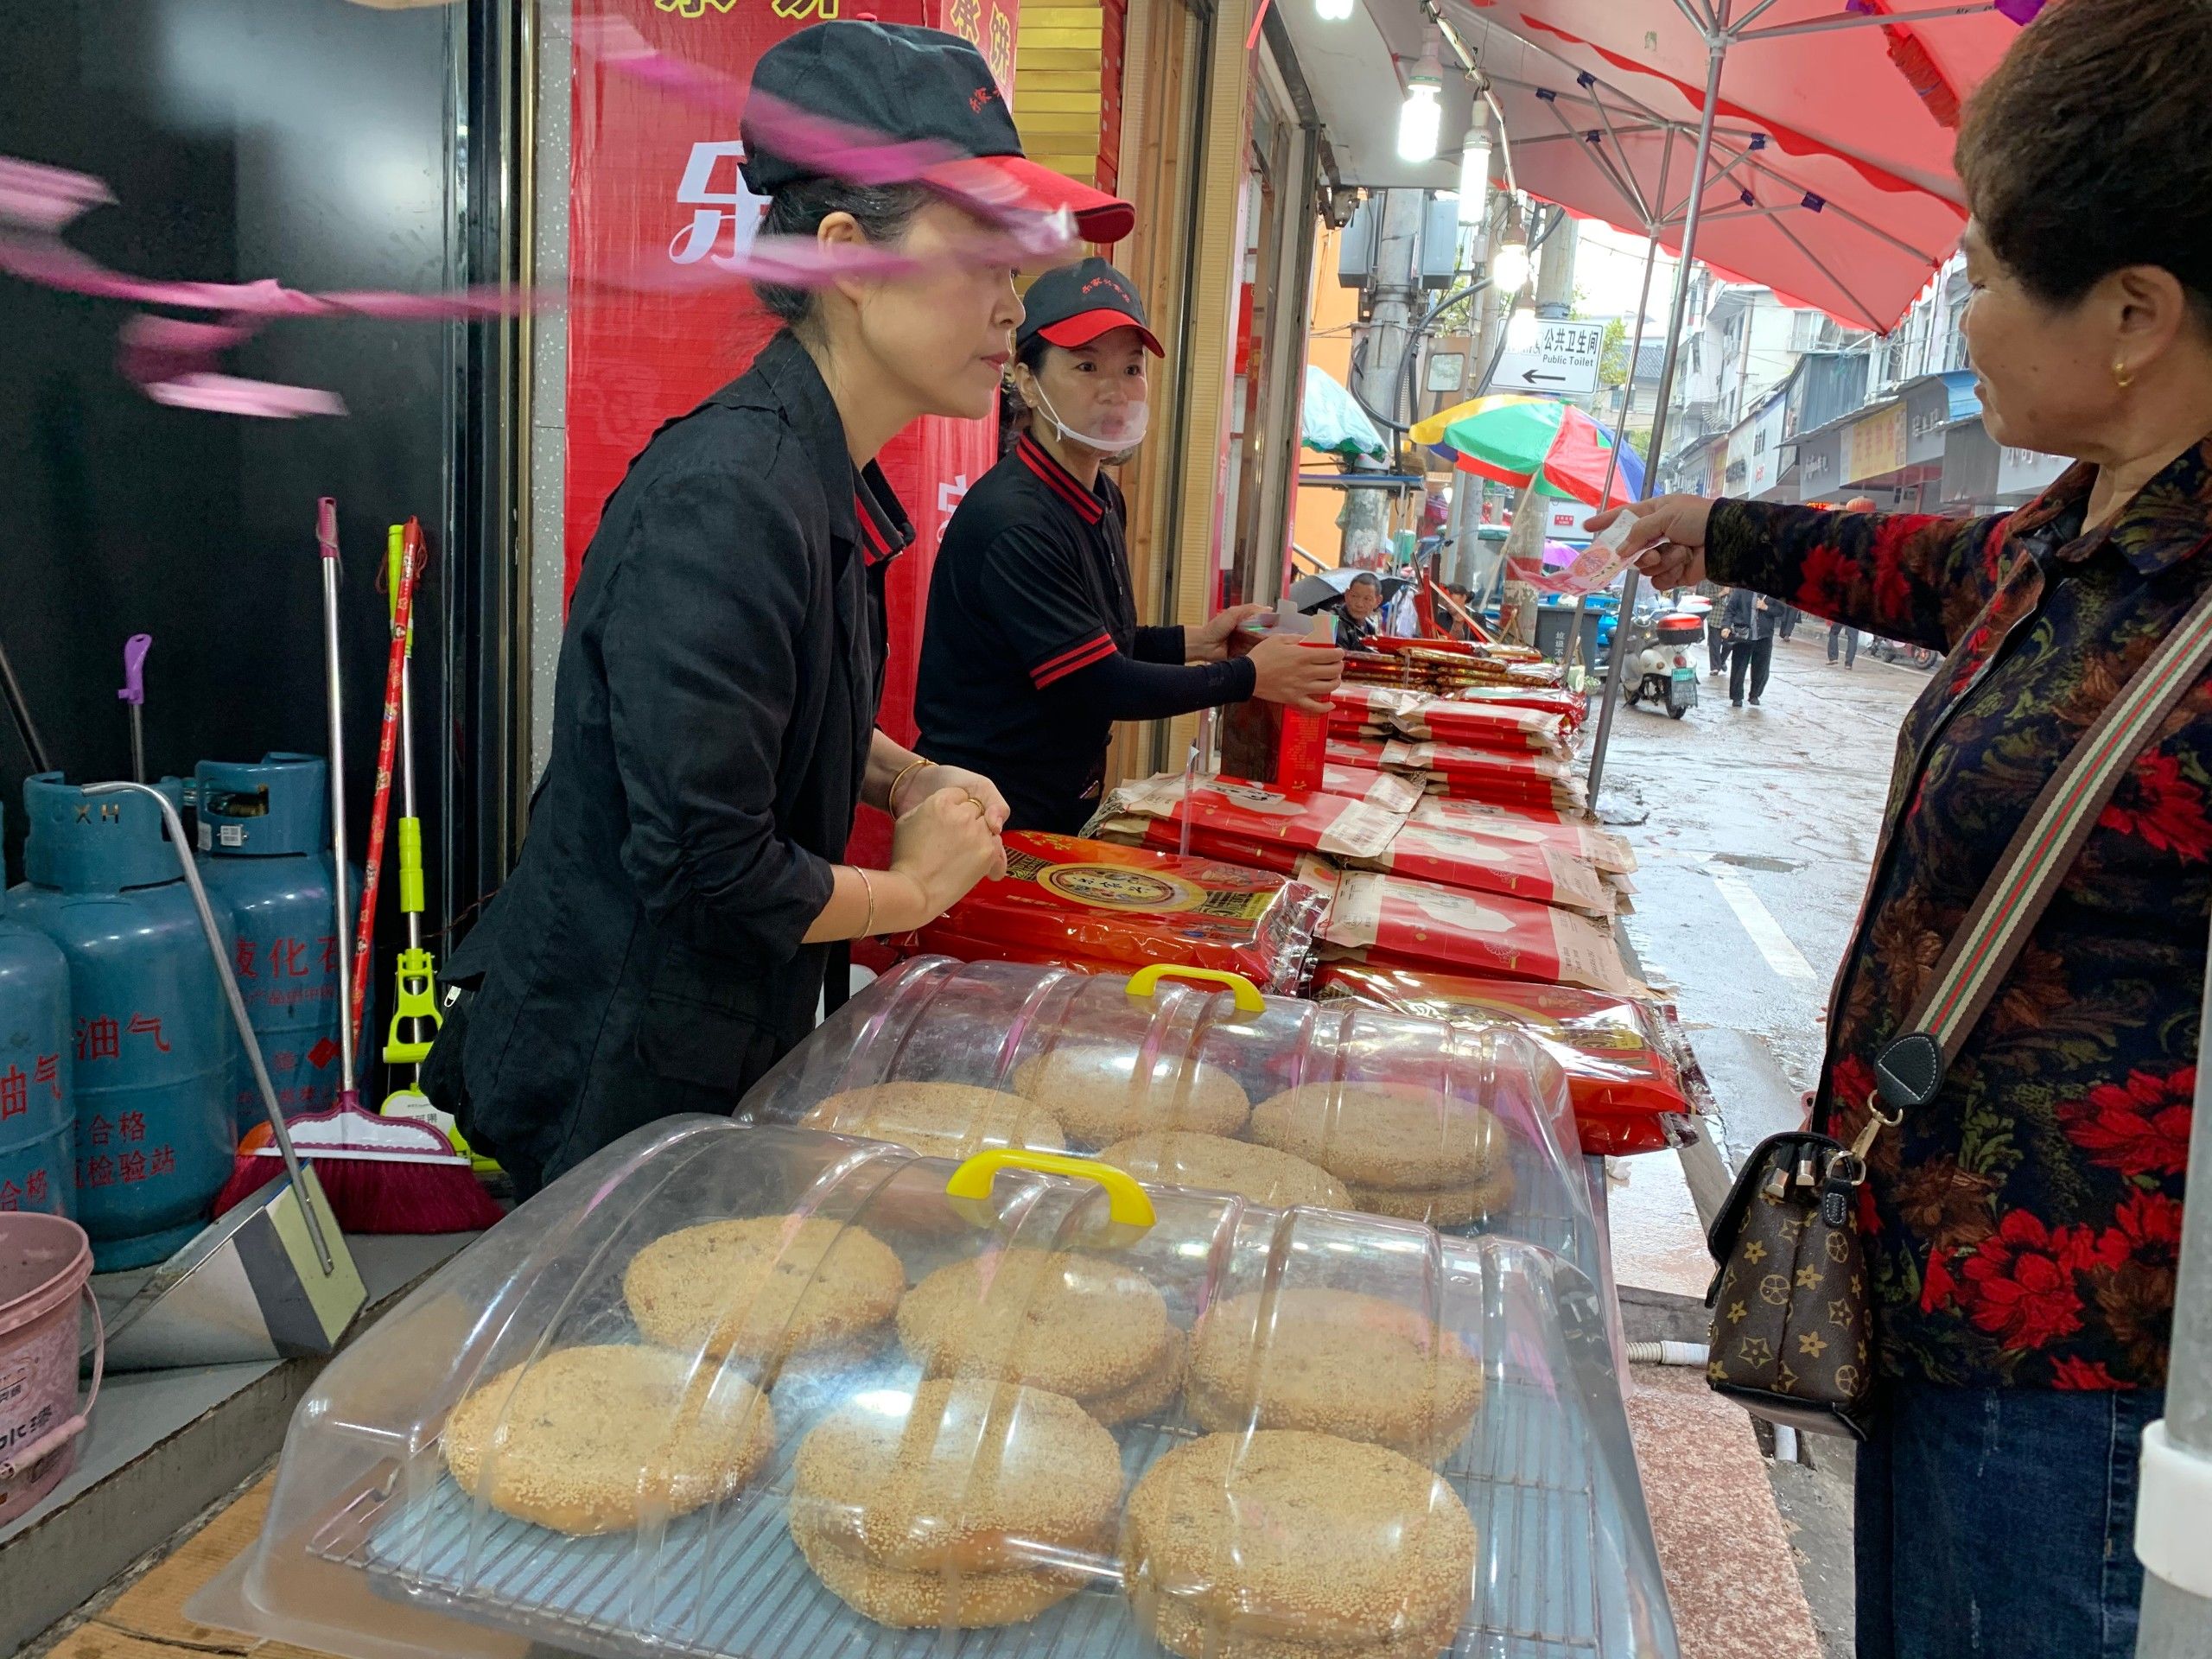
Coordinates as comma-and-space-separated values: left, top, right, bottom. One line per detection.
9, 772, 238, 1272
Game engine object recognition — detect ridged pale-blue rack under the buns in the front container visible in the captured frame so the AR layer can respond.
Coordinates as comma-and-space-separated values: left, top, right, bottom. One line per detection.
309, 1380, 1670, 1659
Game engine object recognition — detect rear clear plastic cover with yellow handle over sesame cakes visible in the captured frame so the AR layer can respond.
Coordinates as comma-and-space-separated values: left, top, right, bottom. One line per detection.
741, 957, 1604, 1283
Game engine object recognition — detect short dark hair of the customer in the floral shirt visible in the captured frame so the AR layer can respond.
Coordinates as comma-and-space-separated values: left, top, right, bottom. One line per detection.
1958, 0, 2212, 319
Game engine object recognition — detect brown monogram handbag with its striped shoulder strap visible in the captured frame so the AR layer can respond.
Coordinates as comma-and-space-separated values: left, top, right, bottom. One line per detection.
1706, 593, 2212, 1440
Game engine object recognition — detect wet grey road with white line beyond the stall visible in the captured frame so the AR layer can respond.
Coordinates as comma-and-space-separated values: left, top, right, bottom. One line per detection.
1606, 620, 1929, 1110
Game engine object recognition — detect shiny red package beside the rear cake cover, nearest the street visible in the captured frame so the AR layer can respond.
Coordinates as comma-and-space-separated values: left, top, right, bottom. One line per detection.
1314, 963, 1692, 1153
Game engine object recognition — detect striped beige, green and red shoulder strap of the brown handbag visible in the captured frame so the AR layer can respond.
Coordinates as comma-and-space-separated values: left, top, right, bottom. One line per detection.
1873, 588, 2212, 1123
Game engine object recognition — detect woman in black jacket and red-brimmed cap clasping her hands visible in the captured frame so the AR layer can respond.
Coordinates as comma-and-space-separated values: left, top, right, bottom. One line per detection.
425, 22, 1130, 1197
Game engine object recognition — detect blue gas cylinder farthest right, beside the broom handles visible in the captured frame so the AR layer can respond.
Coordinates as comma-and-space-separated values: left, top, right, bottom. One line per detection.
193, 754, 356, 1135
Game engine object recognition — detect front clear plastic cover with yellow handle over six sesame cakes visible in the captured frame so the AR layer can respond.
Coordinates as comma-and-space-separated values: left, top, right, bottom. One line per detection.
193, 1117, 1676, 1659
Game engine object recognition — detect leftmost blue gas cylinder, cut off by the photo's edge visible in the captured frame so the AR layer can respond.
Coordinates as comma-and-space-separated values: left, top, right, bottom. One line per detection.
0, 804, 78, 1217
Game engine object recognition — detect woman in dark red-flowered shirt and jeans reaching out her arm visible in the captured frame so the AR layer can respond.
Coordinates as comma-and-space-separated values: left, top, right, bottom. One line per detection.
1592, 0, 2212, 1659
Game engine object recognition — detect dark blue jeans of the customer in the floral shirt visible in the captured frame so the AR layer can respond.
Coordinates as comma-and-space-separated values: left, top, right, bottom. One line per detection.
1858, 1382, 2164, 1659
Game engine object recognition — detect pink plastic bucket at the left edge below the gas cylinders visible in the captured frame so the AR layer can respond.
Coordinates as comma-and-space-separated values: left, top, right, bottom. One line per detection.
0, 1210, 106, 1522
